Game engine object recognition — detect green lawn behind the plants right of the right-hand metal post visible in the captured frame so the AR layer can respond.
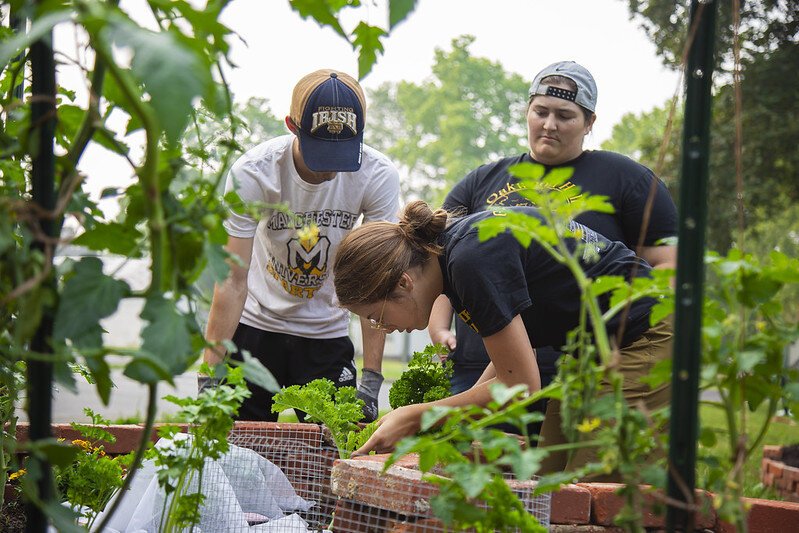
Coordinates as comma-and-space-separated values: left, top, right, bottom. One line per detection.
697, 404, 799, 500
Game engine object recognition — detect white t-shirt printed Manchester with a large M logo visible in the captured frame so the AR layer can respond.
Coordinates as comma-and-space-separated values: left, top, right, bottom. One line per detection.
225, 135, 399, 339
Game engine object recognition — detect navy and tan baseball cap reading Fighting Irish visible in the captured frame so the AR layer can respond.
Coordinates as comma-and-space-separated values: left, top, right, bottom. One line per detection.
289, 69, 366, 172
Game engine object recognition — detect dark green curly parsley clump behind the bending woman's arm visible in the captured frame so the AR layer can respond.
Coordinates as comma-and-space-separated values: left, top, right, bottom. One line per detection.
388, 344, 452, 409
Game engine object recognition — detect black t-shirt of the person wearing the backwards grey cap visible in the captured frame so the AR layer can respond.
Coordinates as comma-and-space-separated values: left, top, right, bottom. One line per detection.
444, 150, 677, 366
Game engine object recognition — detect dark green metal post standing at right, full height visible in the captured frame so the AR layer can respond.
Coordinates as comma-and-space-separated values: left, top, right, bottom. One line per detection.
666, 0, 716, 531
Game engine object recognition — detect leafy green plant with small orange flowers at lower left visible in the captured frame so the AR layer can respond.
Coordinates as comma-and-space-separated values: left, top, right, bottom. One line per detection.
55, 408, 133, 529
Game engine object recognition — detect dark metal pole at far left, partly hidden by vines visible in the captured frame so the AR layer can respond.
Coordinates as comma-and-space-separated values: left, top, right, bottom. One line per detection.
25, 16, 57, 533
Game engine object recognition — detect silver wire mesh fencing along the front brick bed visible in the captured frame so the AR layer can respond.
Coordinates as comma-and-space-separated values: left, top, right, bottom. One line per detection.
225, 423, 550, 533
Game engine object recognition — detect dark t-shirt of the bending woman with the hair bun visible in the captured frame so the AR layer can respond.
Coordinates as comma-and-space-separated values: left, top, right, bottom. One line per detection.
439, 207, 654, 354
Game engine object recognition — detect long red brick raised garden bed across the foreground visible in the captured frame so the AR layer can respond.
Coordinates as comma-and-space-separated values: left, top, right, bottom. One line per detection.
9, 422, 799, 533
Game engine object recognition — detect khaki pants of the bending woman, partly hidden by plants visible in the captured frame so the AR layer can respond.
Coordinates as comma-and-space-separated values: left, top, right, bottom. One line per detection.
538, 319, 673, 482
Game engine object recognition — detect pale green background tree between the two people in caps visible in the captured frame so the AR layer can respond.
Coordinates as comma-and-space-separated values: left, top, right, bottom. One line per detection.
366, 35, 528, 203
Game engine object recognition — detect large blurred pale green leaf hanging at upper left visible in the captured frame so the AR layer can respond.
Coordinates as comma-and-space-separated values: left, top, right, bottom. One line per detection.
108, 23, 216, 143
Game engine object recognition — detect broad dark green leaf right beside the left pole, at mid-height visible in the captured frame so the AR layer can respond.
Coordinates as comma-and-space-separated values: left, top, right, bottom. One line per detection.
53, 257, 130, 347
